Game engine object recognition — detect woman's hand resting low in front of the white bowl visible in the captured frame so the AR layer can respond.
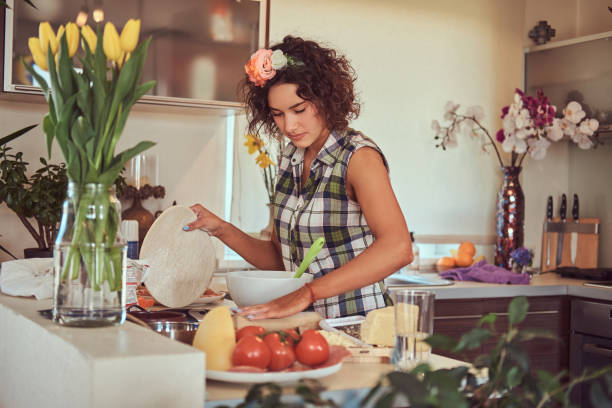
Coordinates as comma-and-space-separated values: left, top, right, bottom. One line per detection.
238, 286, 312, 320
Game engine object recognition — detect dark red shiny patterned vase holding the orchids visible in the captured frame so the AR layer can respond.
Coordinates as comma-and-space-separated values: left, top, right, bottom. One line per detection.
495, 166, 525, 269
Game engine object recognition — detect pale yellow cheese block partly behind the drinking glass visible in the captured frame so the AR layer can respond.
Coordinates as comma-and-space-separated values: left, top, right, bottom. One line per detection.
360, 303, 419, 347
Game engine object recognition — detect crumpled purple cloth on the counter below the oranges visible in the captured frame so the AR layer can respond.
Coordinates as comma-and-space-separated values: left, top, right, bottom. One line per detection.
439, 260, 531, 285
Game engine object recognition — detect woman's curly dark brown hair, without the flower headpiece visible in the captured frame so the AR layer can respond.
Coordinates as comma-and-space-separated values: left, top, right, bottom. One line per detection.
240, 35, 360, 138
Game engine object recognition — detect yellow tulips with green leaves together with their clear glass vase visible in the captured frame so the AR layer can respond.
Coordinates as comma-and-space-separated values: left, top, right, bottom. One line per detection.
24, 19, 155, 326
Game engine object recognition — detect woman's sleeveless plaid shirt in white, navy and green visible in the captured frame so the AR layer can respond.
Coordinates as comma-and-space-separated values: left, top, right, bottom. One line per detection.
274, 129, 391, 318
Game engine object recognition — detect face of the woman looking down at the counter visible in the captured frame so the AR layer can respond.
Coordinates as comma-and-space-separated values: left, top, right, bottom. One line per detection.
268, 84, 329, 150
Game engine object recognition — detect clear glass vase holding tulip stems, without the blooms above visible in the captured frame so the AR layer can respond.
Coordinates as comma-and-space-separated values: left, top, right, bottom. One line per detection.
53, 182, 127, 327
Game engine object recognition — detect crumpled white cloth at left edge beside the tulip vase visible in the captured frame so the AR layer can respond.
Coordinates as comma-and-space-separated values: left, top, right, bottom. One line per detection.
0, 258, 53, 300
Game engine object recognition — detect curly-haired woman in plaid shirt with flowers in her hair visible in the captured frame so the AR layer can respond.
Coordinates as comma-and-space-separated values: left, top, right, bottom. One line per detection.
185, 36, 412, 319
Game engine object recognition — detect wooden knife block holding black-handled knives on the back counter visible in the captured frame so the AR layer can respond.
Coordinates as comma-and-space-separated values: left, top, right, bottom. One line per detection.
540, 218, 599, 272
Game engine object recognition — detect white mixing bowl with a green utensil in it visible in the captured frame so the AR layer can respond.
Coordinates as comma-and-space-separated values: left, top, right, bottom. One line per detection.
225, 271, 312, 306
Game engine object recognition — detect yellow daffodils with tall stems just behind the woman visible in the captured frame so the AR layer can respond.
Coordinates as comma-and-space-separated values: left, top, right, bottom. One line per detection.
244, 134, 284, 239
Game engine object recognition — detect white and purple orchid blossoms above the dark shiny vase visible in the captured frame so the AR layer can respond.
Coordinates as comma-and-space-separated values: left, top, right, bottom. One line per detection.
431, 89, 599, 168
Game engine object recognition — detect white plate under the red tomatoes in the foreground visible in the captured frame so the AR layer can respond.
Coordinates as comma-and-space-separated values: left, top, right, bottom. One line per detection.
206, 362, 342, 384
